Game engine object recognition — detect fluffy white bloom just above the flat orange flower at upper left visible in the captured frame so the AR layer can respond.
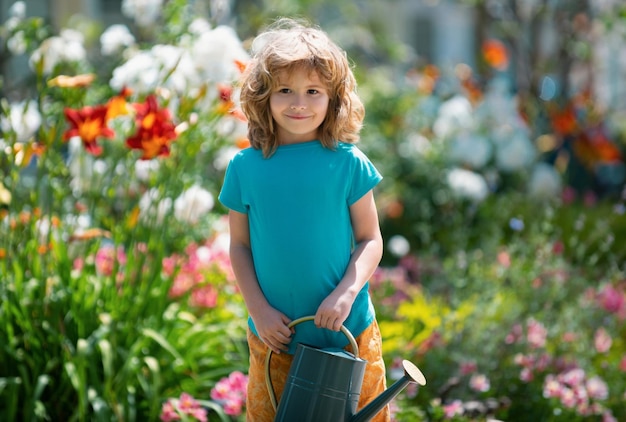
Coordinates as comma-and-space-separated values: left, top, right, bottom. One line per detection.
29, 29, 87, 75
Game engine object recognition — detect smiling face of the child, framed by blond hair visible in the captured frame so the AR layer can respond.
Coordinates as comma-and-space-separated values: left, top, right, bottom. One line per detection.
270, 68, 329, 144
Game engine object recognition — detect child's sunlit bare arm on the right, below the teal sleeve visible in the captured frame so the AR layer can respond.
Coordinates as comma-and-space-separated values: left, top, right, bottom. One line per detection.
315, 190, 383, 331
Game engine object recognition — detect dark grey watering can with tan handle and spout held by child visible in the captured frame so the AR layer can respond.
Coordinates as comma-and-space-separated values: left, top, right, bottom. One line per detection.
265, 316, 426, 422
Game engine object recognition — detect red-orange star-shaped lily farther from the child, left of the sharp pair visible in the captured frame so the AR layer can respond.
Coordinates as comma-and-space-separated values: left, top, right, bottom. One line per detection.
63, 105, 115, 155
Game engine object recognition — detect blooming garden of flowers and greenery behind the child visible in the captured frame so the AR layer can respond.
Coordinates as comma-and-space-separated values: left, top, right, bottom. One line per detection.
0, 0, 626, 422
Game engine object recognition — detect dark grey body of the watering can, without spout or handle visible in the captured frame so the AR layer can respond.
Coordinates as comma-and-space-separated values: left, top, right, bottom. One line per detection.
274, 344, 367, 422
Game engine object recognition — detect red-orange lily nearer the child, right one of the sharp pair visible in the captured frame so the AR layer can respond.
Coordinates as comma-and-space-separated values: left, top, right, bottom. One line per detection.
126, 95, 177, 160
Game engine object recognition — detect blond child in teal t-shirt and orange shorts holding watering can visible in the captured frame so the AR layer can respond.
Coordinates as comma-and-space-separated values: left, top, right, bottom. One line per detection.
219, 19, 389, 422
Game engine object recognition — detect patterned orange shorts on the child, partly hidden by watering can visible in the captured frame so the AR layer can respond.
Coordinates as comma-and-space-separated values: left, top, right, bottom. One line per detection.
246, 321, 390, 422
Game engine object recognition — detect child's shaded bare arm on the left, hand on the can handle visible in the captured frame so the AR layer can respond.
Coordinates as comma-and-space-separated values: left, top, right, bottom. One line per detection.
228, 210, 292, 353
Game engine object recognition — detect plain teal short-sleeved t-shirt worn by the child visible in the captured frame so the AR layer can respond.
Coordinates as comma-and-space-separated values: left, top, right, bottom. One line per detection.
219, 141, 382, 353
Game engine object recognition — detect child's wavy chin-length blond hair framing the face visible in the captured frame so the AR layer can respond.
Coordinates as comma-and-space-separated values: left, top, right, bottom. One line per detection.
240, 18, 365, 157
